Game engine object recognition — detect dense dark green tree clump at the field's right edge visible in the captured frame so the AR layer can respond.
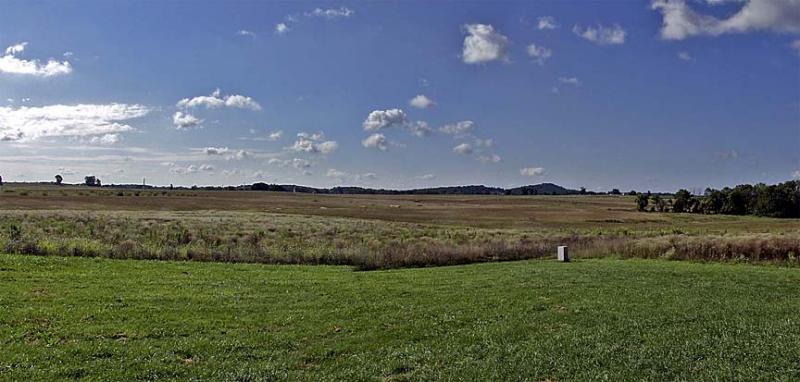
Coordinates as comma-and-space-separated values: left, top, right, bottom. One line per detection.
636, 180, 800, 218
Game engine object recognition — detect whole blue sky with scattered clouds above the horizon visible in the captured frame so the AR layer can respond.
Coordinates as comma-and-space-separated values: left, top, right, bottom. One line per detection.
0, 0, 800, 190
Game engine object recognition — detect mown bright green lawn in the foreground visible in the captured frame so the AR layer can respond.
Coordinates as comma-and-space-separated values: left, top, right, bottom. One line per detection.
0, 255, 800, 381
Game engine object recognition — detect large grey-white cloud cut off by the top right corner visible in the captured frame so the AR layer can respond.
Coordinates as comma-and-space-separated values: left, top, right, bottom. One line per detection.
651, 0, 800, 40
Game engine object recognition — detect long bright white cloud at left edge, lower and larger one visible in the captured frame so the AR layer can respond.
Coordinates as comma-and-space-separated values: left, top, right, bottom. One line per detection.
0, 103, 150, 141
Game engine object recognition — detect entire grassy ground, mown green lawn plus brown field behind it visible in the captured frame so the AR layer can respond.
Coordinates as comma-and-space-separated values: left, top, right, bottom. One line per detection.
0, 185, 800, 381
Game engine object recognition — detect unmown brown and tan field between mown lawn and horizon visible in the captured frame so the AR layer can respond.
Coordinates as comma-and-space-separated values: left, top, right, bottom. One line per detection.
0, 187, 800, 270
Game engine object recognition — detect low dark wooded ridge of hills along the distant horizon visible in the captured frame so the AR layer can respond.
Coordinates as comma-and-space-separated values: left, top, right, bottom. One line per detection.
247, 183, 580, 195
